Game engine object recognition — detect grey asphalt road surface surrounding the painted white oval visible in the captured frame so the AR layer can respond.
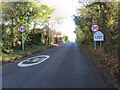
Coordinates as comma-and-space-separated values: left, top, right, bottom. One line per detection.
2, 43, 105, 88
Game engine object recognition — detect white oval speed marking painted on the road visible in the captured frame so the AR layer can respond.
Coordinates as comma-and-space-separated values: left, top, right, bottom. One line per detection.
18, 55, 50, 67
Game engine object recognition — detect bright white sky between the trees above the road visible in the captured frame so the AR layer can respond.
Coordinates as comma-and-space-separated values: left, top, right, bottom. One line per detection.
40, 0, 79, 41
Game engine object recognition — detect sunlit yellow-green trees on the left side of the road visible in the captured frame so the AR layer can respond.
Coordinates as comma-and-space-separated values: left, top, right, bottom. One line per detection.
1, 2, 53, 53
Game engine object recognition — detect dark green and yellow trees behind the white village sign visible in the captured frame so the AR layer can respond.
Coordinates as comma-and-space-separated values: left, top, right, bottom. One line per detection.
75, 2, 120, 56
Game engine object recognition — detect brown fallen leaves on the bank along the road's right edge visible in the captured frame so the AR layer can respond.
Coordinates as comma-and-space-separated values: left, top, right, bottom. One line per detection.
81, 45, 120, 89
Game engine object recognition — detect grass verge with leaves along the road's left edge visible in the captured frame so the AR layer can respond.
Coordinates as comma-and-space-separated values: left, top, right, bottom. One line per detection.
1, 44, 58, 65
